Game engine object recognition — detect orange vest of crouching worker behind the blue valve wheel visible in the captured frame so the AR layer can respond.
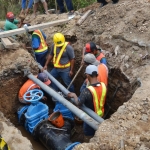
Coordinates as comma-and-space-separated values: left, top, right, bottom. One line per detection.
18, 79, 40, 102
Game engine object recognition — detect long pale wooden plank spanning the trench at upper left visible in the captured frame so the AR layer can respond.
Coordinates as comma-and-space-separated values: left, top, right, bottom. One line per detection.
0, 19, 69, 38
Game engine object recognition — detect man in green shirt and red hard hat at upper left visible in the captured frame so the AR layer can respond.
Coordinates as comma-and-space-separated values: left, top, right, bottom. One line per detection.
4, 12, 23, 31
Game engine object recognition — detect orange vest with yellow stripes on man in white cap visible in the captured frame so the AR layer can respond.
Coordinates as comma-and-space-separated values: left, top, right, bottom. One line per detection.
88, 82, 106, 117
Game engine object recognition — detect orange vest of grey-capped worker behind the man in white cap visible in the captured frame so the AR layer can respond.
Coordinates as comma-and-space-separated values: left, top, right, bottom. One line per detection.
97, 63, 108, 87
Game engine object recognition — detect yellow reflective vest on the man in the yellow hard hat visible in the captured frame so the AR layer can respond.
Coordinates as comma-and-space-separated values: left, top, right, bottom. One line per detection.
53, 42, 70, 68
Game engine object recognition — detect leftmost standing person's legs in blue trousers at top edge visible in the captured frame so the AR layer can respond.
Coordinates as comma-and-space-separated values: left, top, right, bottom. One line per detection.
20, 0, 33, 15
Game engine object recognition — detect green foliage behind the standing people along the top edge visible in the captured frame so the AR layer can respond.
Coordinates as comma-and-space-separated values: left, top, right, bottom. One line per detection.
0, 0, 96, 20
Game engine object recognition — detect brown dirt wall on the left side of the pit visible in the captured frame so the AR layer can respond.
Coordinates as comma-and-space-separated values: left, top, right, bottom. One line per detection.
0, 49, 38, 125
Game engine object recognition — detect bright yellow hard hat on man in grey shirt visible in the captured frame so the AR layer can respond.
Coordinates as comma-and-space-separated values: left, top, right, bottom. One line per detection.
53, 33, 65, 47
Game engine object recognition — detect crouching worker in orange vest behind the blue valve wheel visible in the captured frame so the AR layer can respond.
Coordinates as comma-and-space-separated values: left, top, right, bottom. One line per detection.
18, 72, 51, 104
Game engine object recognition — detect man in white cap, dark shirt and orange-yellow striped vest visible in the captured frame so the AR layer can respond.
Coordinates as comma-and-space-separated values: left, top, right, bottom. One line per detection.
67, 65, 106, 138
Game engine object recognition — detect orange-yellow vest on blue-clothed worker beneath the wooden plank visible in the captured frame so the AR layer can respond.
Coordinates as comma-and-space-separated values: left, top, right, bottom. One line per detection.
33, 30, 48, 53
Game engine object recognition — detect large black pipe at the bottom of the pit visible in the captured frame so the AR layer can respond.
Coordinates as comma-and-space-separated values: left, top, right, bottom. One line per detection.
33, 118, 74, 150
